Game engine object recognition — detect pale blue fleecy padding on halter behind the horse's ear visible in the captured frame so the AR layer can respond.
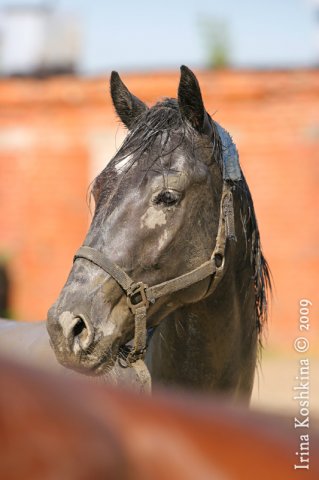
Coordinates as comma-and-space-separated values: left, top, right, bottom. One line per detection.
215, 122, 242, 181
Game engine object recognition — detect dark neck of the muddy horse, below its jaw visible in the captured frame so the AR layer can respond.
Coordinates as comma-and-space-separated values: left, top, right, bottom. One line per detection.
148, 264, 256, 397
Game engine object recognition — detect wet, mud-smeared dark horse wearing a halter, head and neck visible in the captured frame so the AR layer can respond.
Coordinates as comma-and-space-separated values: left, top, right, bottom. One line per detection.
47, 66, 270, 400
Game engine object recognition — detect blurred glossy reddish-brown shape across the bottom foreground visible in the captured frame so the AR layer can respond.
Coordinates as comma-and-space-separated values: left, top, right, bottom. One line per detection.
0, 360, 319, 480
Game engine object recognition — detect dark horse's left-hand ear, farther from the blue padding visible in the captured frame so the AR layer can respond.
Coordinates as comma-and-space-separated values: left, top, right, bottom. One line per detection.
110, 72, 148, 129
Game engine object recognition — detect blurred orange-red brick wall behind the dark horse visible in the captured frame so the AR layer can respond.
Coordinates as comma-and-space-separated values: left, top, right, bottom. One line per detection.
0, 71, 319, 348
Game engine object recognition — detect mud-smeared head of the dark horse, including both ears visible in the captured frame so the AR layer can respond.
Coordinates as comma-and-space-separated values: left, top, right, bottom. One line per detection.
47, 67, 270, 382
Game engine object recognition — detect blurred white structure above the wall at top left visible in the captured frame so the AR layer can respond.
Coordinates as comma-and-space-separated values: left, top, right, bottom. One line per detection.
0, 5, 81, 75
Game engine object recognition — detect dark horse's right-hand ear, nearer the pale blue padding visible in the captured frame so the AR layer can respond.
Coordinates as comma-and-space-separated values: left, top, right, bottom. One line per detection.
178, 65, 211, 135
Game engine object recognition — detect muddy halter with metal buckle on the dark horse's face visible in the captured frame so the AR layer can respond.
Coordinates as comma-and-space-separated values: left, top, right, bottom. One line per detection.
74, 180, 236, 365
